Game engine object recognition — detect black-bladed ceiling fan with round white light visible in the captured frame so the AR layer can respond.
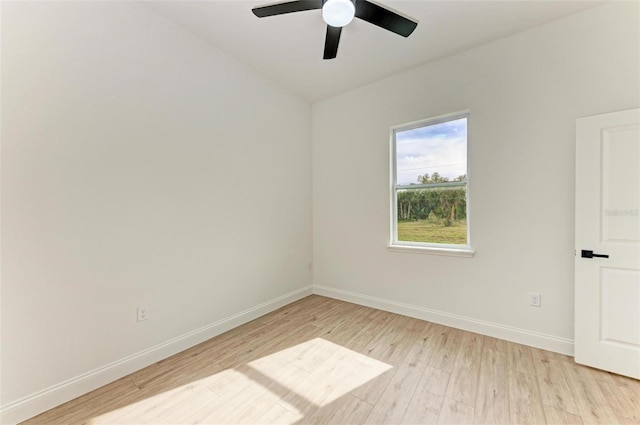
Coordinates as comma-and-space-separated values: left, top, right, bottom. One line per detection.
252, 0, 418, 59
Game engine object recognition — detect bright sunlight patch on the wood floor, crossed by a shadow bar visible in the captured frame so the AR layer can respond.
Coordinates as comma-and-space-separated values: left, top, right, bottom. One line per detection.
89, 338, 392, 425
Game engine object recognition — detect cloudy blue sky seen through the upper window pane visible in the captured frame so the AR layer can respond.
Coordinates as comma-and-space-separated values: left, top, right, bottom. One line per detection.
396, 118, 467, 185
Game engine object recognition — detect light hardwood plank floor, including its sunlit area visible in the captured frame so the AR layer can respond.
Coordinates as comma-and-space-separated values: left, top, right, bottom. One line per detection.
24, 295, 640, 425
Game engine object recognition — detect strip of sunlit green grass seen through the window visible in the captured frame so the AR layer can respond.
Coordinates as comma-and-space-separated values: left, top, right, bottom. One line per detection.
398, 220, 467, 245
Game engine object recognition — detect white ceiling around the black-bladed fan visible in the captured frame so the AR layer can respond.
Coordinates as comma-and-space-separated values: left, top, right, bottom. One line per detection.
144, 0, 603, 102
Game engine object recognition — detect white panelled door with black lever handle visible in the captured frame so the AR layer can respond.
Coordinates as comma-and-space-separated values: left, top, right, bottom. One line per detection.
574, 109, 640, 379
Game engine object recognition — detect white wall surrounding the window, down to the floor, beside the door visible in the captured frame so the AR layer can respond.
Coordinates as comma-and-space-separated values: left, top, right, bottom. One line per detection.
313, 2, 640, 351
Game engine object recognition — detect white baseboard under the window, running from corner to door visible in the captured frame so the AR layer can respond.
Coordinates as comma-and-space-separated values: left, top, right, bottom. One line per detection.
313, 285, 573, 356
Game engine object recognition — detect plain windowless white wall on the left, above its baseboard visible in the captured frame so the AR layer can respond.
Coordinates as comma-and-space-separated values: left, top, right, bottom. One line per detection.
1, 2, 312, 418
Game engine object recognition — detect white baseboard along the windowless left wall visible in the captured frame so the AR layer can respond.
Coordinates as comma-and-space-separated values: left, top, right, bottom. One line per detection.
0, 286, 312, 425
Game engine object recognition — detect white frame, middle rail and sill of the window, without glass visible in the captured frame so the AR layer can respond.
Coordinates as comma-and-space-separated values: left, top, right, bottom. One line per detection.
388, 110, 475, 257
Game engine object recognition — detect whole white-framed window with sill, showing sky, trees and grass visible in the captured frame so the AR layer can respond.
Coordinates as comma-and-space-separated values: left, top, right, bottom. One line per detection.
391, 113, 473, 255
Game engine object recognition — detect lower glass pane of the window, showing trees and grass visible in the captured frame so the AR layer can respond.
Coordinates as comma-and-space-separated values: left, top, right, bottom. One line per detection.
397, 185, 467, 245
